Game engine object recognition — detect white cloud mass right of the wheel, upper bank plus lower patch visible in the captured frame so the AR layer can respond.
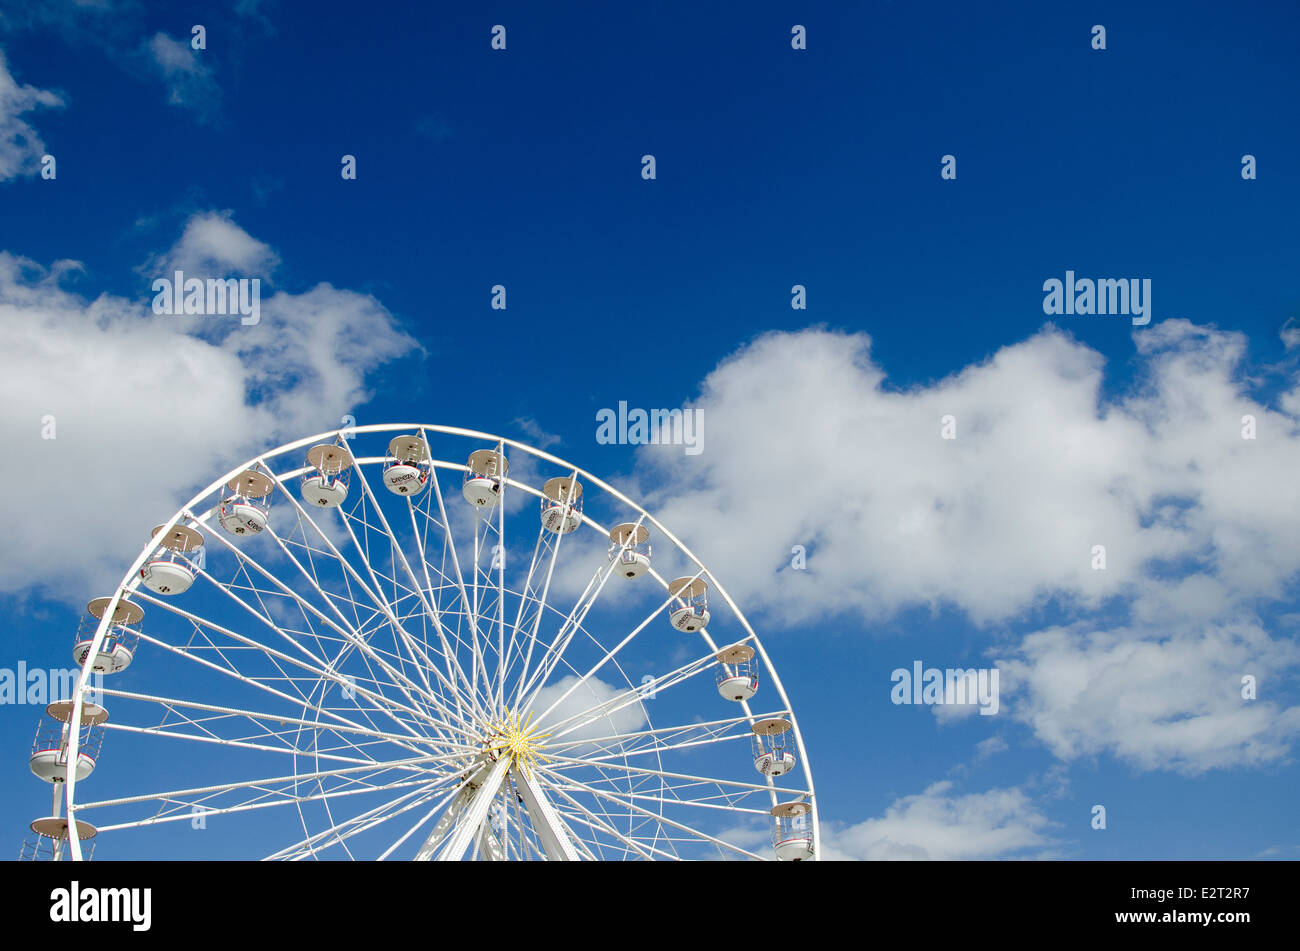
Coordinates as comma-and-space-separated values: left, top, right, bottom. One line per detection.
641, 320, 1300, 772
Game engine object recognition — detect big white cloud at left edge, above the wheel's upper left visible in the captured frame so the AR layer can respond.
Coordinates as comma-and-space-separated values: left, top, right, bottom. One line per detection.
0, 216, 416, 602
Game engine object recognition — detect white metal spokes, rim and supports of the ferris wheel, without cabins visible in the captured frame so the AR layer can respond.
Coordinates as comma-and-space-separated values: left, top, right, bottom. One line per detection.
64, 424, 820, 860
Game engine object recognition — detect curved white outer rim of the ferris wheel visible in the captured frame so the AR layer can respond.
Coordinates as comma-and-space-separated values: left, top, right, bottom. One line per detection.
64, 422, 822, 861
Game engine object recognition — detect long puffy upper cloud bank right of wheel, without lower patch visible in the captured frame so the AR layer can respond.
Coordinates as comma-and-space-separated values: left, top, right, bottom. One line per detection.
644, 321, 1300, 622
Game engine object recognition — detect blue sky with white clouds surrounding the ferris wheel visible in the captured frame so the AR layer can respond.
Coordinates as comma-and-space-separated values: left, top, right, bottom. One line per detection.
0, 0, 1300, 859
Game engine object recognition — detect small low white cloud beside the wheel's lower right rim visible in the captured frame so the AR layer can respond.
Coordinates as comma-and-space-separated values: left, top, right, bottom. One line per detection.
822, 781, 1052, 860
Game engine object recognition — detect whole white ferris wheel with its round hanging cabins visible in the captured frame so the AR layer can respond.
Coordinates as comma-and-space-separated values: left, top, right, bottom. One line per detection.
25, 425, 819, 861
